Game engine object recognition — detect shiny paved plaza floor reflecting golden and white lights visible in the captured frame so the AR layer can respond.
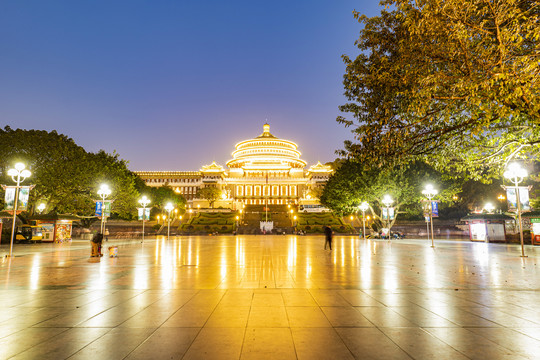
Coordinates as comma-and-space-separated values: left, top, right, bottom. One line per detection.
0, 235, 540, 359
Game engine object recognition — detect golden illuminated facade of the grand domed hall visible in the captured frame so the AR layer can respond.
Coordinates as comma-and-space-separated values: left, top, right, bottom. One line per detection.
136, 124, 332, 207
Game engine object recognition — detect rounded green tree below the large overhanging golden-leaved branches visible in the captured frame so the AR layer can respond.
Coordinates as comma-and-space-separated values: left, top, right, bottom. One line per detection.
321, 161, 457, 228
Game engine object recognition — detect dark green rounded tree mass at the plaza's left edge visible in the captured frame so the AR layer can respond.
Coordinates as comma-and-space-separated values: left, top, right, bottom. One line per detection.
0, 127, 139, 219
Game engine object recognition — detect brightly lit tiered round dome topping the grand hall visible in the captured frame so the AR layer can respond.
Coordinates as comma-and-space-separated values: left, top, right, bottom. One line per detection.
227, 124, 306, 170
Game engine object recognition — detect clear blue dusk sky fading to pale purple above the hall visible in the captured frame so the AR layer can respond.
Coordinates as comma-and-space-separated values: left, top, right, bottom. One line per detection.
0, 0, 380, 170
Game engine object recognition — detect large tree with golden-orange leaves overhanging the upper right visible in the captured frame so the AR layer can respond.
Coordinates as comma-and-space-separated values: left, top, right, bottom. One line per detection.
337, 0, 540, 179
